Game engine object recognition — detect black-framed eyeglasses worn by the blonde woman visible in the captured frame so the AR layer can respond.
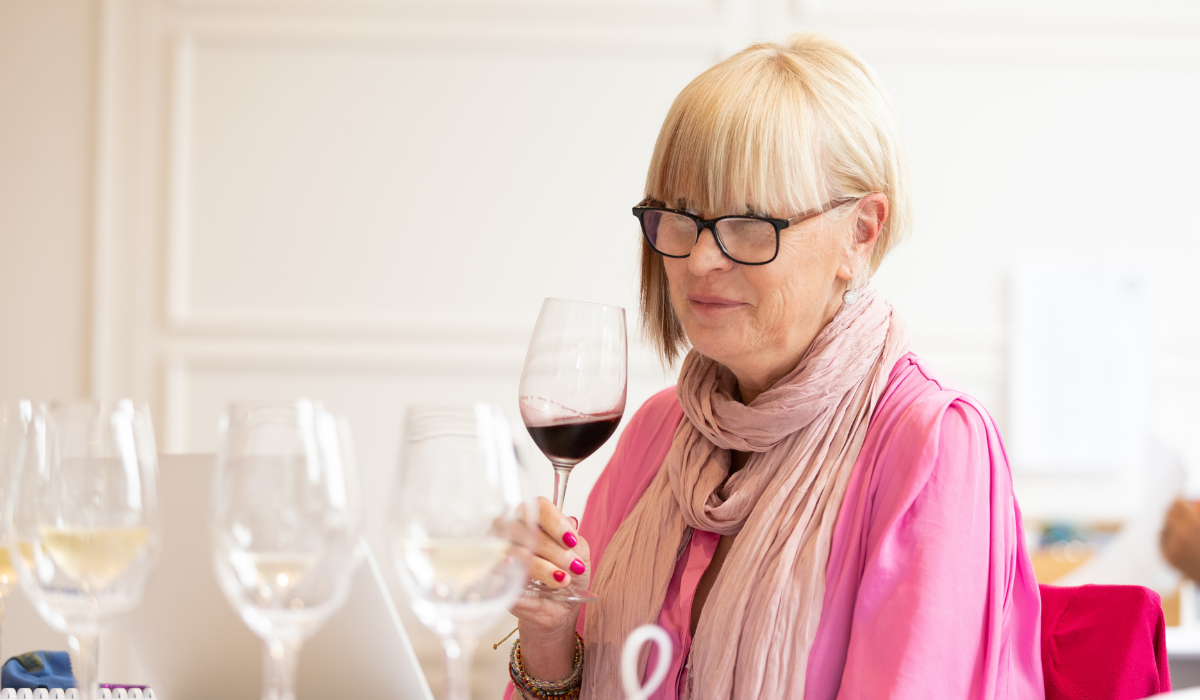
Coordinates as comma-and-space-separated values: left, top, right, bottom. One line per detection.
634, 197, 862, 265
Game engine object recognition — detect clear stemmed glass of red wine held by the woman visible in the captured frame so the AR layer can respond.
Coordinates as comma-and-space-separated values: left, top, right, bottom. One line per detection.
521, 299, 629, 603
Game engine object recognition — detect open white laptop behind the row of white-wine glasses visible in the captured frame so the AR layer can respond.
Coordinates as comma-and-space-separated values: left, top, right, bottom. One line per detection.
127, 455, 433, 700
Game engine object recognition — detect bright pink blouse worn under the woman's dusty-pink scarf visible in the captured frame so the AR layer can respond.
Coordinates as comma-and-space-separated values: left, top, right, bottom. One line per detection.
505, 354, 1045, 700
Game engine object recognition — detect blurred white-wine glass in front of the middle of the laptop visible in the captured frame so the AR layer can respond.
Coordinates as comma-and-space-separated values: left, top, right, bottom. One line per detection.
211, 399, 362, 700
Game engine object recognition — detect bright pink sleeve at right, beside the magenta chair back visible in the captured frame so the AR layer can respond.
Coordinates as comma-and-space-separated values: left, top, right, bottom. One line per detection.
838, 400, 1043, 700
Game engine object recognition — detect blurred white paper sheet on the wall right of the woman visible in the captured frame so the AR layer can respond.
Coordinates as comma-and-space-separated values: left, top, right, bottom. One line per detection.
1009, 262, 1153, 475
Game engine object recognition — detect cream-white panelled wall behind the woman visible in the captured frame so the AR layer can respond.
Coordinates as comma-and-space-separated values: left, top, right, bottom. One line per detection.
0, 0, 1200, 696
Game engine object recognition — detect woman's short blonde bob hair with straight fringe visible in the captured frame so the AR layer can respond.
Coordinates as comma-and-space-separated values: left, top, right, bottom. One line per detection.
641, 34, 912, 364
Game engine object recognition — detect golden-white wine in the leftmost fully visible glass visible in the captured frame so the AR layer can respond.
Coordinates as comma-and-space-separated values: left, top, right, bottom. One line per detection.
41, 527, 150, 588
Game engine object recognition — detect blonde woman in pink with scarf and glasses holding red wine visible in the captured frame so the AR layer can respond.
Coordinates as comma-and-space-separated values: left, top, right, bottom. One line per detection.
511, 35, 1044, 700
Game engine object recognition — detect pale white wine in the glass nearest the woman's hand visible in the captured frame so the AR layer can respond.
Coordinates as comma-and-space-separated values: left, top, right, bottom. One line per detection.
403, 538, 510, 598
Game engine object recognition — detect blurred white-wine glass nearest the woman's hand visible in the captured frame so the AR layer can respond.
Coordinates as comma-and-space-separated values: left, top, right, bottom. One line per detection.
388, 403, 533, 700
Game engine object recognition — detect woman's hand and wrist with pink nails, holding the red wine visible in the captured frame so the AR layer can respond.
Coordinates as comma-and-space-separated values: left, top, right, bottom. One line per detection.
511, 497, 592, 681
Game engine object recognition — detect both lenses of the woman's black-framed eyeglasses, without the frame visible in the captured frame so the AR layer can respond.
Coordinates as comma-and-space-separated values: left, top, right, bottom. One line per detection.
642, 211, 778, 263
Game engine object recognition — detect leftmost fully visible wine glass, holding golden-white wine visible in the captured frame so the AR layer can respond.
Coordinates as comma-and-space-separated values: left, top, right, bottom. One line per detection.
7, 400, 162, 700
